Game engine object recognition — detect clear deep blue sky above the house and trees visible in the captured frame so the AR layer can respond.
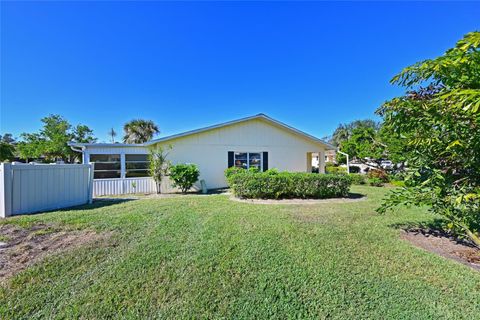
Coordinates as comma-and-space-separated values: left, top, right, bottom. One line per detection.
0, 1, 480, 141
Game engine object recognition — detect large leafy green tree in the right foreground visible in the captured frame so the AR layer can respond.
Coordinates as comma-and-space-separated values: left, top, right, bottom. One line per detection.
377, 32, 480, 247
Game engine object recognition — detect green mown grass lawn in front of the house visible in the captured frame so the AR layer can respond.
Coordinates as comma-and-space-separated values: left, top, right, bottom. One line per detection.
0, 187, 480, 319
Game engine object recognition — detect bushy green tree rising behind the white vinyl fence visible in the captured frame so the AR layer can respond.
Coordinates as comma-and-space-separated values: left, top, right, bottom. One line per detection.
18, 114, 96, 162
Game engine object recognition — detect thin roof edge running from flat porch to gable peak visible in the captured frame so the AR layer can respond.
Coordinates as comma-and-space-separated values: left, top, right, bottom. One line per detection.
69, 113, 336, 150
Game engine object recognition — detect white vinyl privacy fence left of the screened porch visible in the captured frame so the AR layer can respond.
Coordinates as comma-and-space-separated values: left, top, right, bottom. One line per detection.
0, 163, 93, 218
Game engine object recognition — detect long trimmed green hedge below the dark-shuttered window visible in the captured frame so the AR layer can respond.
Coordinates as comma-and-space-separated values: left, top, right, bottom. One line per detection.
226, 170, 352, 199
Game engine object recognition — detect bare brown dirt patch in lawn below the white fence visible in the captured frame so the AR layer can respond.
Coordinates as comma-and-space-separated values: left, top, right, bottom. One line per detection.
0, 224, 105, 283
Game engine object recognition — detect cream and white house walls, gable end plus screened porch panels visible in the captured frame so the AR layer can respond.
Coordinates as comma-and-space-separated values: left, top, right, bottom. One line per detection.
84, 119, 325, 196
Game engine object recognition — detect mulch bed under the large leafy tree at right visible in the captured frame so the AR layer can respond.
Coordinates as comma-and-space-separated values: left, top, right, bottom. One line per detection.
401, 229, 480, 271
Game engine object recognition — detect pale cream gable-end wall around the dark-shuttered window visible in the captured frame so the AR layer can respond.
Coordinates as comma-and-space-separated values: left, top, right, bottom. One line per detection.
154, 119, 325, 189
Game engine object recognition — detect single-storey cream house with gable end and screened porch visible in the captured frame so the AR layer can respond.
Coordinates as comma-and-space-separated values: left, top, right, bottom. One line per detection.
70, 114, 334, 195
